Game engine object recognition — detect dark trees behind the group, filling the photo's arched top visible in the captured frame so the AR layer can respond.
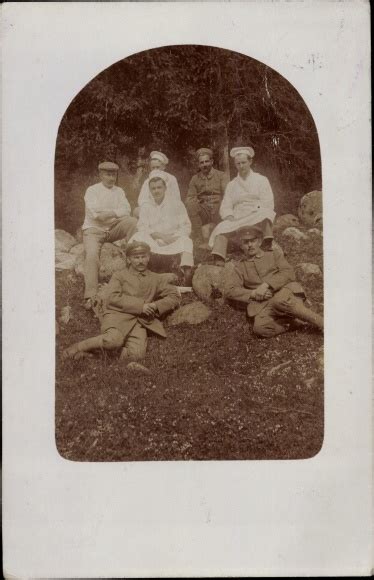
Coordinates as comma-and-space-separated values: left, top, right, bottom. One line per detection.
55, 45, 321, 231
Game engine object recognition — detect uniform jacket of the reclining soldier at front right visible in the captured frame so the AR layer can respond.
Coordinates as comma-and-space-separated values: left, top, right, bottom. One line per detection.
225, 250, 304, 316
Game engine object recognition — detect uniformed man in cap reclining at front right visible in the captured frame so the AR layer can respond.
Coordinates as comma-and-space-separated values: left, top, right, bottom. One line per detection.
225, 226, 323, 338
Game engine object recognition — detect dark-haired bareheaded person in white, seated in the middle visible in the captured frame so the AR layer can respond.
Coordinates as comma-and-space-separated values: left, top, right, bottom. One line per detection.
130, 169, 193, 278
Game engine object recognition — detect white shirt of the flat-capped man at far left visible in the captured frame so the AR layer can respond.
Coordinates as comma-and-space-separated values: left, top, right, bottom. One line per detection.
82, 182, 131, 232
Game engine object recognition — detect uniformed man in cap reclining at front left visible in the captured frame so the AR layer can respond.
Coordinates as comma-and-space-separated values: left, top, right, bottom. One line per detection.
62, 242, 180, 370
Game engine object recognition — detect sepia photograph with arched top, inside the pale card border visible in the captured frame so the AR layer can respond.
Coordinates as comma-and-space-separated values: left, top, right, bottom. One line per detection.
55, 44, 324, 462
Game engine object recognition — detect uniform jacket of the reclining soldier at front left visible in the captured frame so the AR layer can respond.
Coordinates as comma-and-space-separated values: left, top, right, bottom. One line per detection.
101, 267, 180, 337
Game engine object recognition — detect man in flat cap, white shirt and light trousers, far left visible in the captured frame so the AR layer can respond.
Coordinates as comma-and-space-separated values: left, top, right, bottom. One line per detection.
82, 161, 137, 310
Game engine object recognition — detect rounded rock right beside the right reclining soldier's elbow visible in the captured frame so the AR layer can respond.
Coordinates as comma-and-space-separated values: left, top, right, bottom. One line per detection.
192, 262, 234, 302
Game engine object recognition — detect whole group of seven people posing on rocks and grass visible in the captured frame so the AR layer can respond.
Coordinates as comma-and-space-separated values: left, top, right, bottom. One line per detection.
63, 147, 323, 370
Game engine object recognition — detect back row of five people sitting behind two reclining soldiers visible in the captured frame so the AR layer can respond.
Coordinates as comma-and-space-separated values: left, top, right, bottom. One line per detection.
82, 147, 275, 310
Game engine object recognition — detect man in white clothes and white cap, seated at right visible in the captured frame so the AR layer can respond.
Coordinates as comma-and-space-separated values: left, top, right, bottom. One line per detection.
209, 147, 275, 264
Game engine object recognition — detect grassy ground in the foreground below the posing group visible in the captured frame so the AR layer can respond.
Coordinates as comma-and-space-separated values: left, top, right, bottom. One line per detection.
56, 234, 324, 461
